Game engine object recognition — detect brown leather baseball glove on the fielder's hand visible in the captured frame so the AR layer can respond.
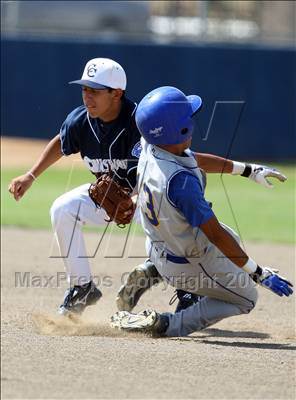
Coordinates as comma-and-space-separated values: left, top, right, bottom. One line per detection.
88, 173, 135, 227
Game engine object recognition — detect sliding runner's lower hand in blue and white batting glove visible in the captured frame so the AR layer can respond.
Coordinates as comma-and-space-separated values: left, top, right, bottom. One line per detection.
251, 267, 293, 297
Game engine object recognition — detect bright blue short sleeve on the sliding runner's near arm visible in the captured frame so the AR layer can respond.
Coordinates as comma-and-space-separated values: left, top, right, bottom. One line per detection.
168, 171, 214, 227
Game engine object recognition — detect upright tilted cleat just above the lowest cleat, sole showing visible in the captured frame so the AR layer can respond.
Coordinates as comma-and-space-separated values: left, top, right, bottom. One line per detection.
116, 259, 161, 311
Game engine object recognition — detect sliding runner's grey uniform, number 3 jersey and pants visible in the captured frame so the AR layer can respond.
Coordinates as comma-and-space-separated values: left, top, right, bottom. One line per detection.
138, 139, 257, 336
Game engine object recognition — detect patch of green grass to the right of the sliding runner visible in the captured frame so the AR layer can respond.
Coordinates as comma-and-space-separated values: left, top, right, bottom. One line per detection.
206, 165, 296, 243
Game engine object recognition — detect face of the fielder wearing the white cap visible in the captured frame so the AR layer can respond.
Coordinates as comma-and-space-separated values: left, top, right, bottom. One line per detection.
82, 86, 119, 121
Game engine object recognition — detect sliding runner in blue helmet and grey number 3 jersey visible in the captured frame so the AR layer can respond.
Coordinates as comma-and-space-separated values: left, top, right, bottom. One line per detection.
111, 86, 293, 336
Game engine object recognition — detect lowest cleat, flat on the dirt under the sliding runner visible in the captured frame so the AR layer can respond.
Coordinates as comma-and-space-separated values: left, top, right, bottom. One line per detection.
110, 310, 169, 336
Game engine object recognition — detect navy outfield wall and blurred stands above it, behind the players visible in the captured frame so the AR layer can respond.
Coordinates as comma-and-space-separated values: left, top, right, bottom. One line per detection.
1, 1, 296, 161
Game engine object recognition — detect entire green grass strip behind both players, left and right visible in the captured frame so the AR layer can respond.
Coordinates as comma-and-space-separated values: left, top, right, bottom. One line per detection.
1, 165, 296, 243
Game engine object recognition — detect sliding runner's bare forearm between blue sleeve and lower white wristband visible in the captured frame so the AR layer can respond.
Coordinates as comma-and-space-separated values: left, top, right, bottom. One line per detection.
200, 217, 249, 268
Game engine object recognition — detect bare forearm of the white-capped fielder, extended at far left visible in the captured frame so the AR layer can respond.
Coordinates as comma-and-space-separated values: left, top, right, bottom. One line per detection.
30, 135, 63, 178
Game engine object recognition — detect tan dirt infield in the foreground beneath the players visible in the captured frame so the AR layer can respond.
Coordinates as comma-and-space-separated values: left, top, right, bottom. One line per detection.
1, 228, 296, 399
